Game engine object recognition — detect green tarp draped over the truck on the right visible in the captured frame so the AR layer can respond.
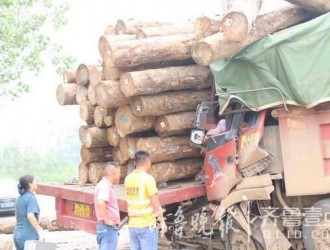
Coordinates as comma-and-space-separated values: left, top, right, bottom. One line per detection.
210, 13, 330, 113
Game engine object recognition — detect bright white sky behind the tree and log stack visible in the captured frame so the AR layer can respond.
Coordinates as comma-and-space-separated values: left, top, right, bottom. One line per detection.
0, 0, 286, 150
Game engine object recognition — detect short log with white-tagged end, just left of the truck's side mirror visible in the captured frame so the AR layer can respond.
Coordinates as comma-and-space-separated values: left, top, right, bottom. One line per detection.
155, 112, 196, 137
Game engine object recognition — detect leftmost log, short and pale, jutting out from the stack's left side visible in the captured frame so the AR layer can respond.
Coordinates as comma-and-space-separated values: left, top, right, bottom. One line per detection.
56, 83, 78, 105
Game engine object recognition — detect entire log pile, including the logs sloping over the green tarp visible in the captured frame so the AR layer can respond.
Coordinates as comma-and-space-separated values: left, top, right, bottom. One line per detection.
57, 0, 330, 184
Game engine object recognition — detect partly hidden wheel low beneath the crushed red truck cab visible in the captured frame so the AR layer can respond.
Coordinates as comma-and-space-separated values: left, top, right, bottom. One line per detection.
229, 229, 257, 250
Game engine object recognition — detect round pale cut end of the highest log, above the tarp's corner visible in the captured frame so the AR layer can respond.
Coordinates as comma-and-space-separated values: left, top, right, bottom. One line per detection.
222, 12, 249, 42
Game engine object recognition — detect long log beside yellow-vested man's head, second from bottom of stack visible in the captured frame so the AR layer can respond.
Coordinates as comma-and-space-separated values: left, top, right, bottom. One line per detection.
136, 136, 200, 162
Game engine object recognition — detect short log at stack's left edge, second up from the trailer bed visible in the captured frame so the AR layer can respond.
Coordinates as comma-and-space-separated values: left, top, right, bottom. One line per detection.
80, 146, 112, 165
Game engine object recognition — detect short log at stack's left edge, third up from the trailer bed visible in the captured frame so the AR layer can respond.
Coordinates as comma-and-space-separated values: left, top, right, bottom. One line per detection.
82, 127, 110, 148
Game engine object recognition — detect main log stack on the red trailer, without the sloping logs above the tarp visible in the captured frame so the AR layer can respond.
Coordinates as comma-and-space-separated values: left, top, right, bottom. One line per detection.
57, 20, 214, 184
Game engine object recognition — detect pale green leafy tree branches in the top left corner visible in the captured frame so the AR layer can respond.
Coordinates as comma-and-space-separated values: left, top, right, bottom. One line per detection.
0, 0, 74, 97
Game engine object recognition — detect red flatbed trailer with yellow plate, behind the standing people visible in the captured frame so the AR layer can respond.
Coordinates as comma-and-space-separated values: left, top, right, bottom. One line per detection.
38, 180, 206, 233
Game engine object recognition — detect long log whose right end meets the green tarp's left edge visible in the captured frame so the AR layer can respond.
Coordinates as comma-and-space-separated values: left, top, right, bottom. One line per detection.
120, 65, 213, 97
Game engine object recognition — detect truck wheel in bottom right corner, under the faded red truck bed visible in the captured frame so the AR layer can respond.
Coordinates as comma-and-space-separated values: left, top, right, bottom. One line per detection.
303, 199, 330, 250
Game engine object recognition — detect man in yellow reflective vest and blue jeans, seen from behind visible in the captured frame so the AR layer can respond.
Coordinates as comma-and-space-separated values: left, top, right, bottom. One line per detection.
125, 151, 167, 250
